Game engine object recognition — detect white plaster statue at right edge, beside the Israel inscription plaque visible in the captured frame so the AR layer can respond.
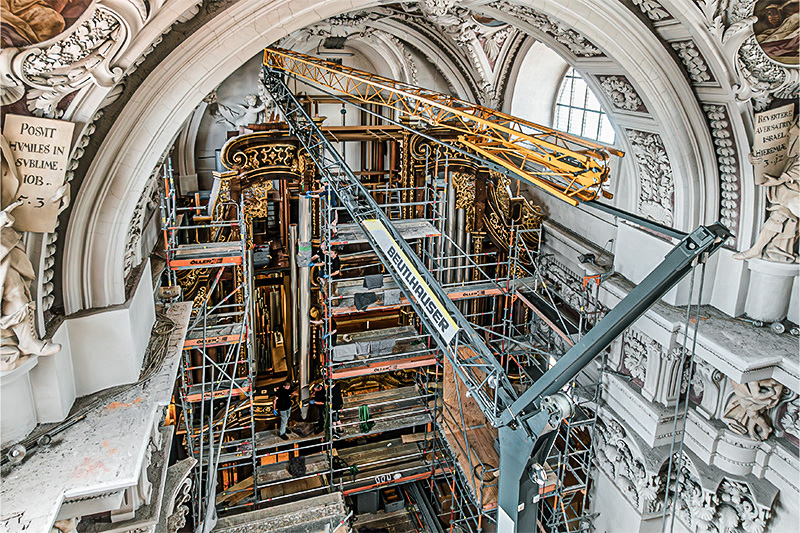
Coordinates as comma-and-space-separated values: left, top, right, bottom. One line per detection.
733, 117, 800, 263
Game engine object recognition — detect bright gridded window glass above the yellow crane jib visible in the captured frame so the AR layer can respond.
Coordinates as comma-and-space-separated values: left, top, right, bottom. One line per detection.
554, 67, 616, 144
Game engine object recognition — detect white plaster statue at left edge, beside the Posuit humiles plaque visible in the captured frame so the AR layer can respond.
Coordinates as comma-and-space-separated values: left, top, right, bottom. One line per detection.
0, 138, 64, 372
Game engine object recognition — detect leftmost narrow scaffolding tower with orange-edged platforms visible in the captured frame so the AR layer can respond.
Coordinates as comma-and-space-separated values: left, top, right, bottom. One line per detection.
161, 160, 258, 522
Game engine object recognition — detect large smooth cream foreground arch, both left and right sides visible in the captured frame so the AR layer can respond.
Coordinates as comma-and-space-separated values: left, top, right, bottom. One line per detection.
63, 0, 717, 313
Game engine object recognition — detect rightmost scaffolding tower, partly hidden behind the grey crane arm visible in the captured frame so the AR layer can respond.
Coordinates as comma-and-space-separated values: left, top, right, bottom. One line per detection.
505, 228, 606, 532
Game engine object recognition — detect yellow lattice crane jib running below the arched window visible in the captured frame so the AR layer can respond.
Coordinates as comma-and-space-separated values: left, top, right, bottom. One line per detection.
264, 48, 624, 205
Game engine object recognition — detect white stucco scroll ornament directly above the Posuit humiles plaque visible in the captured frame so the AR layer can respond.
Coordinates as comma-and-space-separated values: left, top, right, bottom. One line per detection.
2, 6, 127, 118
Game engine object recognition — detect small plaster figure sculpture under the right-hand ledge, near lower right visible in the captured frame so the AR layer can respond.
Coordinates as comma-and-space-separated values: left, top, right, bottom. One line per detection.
723, 378, 783, 441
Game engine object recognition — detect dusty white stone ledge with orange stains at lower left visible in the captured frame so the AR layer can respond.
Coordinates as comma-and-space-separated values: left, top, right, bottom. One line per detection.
0, 303, 191, 533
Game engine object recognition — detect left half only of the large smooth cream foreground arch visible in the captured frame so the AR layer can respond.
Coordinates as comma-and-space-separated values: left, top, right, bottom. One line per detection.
62, 0, 372, 314
